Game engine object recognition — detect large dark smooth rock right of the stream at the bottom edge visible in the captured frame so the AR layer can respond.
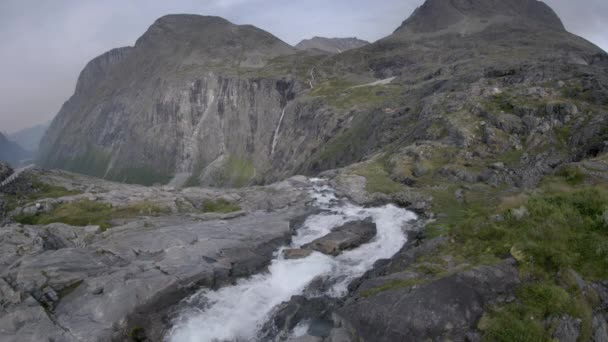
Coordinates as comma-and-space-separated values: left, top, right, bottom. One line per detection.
337, 260, 519, 342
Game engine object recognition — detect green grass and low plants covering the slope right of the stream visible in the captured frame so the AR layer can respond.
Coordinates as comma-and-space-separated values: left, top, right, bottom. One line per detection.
361, 163, 608, 341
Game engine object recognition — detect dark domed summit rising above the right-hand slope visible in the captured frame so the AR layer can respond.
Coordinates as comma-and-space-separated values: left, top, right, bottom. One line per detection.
395, 0, 565, 33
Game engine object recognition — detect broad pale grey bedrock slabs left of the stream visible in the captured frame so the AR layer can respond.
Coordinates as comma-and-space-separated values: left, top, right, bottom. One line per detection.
0, 171, 309, 341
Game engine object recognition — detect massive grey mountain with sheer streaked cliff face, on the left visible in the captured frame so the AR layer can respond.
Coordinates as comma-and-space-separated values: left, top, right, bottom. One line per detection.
40, 15, 297, 186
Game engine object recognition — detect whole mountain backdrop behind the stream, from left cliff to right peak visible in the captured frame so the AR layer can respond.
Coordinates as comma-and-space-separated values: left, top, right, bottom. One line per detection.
40, 0, 608, 191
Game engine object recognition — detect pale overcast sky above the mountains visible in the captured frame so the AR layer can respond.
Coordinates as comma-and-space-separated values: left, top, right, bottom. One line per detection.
0, 0, 608, 133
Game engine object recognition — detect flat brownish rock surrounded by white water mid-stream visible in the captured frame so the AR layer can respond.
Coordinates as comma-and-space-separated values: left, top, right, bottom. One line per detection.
302, 219, 377, 256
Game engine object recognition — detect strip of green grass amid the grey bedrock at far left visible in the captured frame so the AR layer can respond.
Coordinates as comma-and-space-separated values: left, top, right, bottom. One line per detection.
13, 199, 168, 230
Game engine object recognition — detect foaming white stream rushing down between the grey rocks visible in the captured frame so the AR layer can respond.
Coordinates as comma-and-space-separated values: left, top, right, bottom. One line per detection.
166, 179, 416, 342
